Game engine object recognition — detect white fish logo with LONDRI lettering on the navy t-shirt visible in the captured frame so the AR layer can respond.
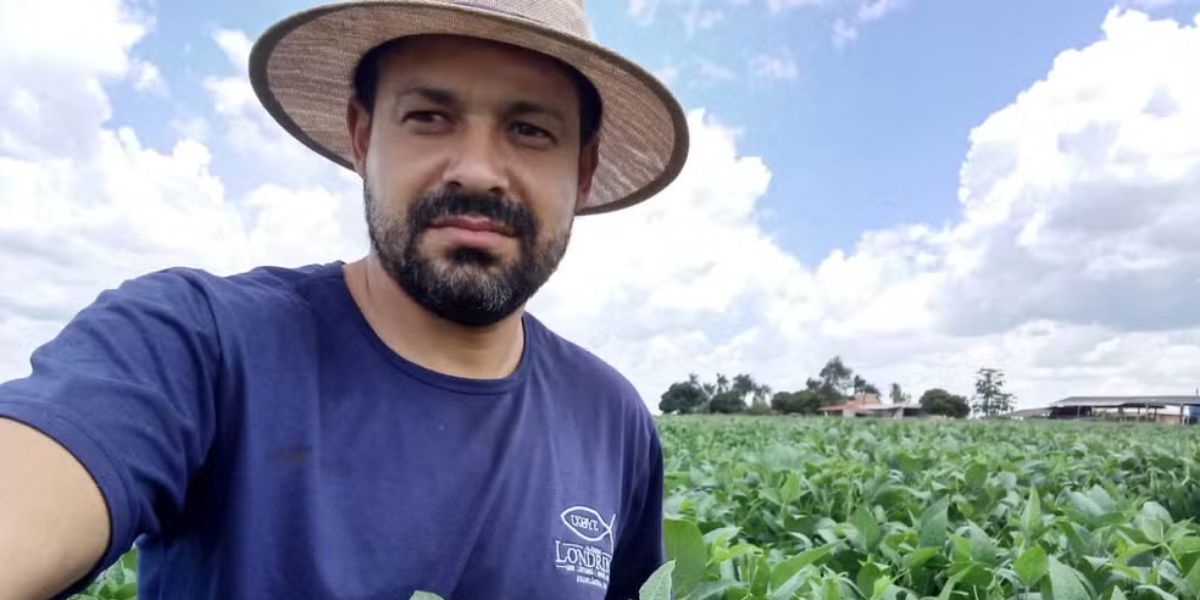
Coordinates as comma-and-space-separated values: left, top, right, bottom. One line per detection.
554, 505, 617, 589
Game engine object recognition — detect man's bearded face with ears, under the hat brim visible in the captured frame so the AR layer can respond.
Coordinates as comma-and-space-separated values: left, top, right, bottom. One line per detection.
349, 36, 595, 326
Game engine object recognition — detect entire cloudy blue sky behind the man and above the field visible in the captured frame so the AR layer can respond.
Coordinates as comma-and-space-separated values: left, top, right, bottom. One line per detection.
0, 0, 1200, 408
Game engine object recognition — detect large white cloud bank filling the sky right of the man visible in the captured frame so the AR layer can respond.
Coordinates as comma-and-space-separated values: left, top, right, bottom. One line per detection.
535, 11, 1200, 406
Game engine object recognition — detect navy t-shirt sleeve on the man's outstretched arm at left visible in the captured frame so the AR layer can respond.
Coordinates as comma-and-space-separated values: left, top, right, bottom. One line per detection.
0, 271, 220, 598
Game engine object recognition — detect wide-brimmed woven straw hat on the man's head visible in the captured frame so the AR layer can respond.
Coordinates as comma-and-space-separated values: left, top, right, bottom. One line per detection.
250, 0, 688, 215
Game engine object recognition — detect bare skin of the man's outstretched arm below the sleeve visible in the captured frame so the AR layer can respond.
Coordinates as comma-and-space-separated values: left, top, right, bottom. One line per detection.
0, 418, 109, 600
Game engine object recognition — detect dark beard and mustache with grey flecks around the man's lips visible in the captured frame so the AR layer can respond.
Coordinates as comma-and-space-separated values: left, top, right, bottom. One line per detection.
362, 181, 571, 328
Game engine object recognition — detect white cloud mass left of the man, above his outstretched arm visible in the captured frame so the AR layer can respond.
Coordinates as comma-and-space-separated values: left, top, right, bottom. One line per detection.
0, 7, 364, 379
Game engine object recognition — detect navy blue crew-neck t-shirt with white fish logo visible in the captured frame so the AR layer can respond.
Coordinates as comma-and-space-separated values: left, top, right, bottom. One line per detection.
0, 263, 662, 600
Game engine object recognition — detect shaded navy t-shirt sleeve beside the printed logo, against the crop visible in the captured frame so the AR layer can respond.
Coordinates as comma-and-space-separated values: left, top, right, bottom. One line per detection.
606, 416, 665, 600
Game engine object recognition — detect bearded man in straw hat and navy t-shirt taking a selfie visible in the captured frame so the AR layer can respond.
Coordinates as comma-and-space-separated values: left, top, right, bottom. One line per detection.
0, 0, 688, 600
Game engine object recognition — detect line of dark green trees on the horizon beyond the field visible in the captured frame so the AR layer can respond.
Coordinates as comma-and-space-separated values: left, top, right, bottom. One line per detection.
659, 356, 1015, 419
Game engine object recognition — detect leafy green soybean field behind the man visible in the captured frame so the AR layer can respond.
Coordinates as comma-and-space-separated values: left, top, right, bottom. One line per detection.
72, 416, 1200, 600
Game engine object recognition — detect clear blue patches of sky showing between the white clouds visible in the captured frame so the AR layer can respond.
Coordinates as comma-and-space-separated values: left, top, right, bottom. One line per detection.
115, 0, 1196, 262
